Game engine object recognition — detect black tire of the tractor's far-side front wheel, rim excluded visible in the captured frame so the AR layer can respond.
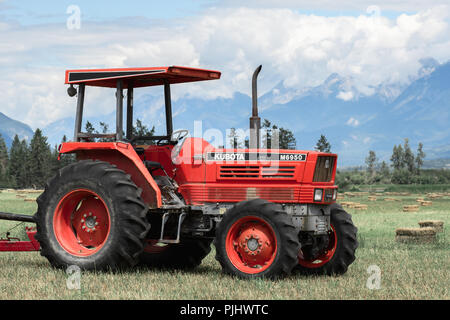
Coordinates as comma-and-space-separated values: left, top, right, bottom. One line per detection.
295, 203, 358, 275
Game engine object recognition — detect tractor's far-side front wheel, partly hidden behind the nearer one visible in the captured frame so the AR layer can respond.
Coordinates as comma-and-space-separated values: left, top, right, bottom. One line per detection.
294, 203, 358, 275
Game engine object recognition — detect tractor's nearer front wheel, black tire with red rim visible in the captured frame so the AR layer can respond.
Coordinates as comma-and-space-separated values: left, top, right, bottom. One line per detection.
214, 199, 300, 278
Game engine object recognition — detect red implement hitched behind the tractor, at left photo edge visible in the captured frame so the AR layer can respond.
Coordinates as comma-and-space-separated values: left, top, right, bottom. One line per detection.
0, 212, 41, 252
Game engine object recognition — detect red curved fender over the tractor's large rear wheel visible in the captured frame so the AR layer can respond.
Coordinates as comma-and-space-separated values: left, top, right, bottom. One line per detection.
58, 142, 162, 208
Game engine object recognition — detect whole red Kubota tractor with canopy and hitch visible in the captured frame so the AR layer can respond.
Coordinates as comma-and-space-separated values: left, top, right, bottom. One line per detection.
0, 66, 358, 278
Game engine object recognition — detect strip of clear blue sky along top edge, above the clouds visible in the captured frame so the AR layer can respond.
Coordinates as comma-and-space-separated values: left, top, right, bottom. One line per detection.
0, 0, 430, 25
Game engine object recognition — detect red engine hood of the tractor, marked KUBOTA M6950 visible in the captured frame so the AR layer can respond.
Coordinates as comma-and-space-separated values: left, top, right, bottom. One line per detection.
141, 138, 337, 205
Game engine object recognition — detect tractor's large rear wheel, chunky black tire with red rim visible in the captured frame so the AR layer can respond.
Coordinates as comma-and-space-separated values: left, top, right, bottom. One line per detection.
35, 160, 150, 270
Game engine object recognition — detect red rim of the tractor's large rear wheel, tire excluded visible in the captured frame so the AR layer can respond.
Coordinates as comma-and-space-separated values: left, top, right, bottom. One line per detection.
53, 189, 111, 257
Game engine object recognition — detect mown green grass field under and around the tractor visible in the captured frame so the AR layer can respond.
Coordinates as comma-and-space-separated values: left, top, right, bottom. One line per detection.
0, 191, 450, 300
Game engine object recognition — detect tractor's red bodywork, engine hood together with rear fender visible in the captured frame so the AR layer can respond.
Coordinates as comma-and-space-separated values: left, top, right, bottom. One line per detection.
60, 138, 337, 208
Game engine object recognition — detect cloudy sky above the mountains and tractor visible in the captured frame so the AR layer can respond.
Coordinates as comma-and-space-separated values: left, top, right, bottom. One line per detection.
0, 0, 450, 128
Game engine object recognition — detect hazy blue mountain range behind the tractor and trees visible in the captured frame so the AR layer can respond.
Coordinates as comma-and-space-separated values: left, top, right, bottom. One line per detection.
0, 58, 450, 166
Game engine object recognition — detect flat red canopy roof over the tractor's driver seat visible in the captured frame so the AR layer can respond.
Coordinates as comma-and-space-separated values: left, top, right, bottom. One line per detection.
65, 66, 221, 88
